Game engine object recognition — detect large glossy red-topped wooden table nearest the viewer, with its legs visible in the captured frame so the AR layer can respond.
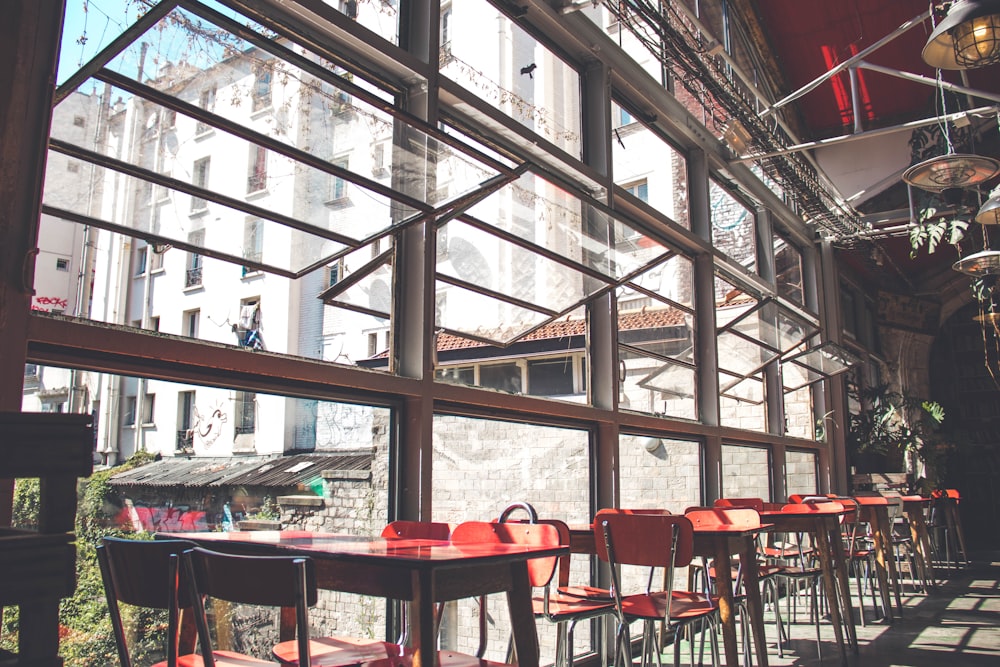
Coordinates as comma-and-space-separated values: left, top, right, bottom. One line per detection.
156, 531, 567, 667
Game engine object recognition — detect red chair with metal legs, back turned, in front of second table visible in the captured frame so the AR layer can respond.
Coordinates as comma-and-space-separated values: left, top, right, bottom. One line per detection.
594, 510, 719, 667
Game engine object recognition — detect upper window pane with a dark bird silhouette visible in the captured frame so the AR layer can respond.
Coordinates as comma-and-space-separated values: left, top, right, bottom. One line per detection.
440, 0, 583, 158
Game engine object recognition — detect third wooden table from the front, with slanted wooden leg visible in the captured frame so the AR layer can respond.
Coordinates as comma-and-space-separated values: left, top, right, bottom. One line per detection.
760, 509, 858, 664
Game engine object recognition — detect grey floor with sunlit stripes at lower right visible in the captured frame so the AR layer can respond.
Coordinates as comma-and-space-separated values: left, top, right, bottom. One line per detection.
748, 552, 1000, 667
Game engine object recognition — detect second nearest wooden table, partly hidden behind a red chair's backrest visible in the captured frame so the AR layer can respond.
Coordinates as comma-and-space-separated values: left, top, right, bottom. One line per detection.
570, 526, 768, 667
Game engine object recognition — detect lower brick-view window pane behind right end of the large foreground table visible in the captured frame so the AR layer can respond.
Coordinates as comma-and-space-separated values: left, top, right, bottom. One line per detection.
431, 415, 591, 662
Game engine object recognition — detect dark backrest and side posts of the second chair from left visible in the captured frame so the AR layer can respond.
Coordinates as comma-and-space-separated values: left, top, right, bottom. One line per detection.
182, 547, 316, 667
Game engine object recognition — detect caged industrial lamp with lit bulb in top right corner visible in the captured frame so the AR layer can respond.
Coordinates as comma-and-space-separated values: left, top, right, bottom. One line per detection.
920, 0, 1000, 69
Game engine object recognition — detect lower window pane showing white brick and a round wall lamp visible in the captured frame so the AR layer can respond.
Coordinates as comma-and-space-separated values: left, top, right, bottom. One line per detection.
618, 433, 702, 514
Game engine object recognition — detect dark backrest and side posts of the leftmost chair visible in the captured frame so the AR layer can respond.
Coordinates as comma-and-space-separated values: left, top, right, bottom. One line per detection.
97, 537, 195, 667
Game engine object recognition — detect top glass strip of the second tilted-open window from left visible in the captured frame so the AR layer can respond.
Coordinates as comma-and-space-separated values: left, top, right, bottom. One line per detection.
468, 173, 667, 280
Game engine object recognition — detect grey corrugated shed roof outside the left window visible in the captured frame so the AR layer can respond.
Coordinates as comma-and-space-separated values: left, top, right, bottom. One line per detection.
110, 450, 373, 488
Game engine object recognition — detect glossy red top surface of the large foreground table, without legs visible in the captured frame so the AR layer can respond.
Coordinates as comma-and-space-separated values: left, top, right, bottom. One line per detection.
156, 530, 569, 565
